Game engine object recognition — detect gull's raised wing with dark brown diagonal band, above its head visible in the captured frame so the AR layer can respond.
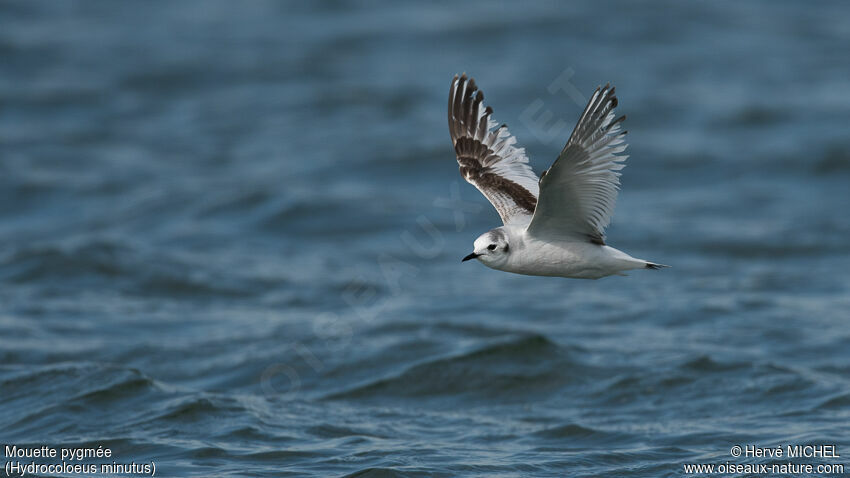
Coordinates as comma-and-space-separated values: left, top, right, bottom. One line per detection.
449, 74, 539, 225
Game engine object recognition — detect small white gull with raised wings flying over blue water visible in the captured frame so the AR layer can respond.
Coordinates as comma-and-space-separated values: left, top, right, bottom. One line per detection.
449, 74, 669, 279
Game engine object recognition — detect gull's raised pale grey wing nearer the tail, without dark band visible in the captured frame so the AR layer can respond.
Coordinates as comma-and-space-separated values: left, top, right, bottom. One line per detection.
527, 85, 628, 244
